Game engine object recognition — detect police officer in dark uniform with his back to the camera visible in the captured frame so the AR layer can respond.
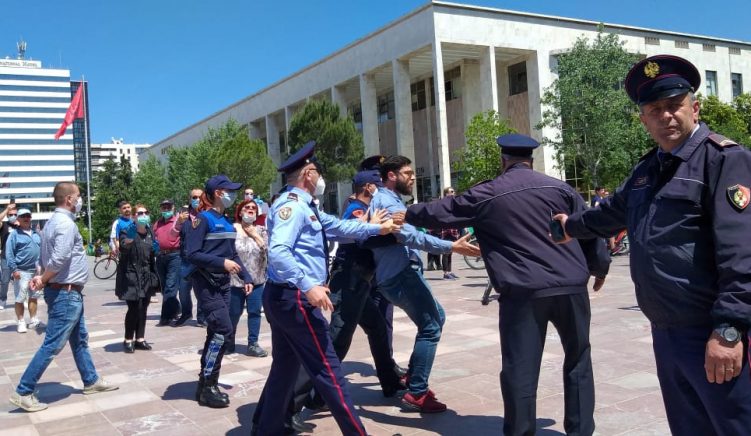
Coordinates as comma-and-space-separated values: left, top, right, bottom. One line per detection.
405, 134, 610, 435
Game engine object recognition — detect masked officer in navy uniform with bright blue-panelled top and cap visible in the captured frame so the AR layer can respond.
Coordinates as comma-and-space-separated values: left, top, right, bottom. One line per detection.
185, 174, 253, 408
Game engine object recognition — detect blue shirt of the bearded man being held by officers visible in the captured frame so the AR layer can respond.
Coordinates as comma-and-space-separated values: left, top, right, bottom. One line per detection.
370, 188, 452, 283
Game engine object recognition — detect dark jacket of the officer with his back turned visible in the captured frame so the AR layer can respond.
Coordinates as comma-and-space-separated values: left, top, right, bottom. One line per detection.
406, 164, 610, 298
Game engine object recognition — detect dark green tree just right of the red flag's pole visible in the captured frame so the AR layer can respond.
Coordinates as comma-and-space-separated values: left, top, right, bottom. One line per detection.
91, 157, 133, 240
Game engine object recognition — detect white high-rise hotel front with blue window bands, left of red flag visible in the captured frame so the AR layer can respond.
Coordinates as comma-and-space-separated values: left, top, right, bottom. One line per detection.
0, 55, 76, 220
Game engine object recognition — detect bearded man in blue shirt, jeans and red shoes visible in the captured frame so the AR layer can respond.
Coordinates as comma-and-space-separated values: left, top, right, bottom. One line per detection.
370, 156, 480, 413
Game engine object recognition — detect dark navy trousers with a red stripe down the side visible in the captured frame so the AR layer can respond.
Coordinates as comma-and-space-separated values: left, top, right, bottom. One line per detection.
253, 283, 366, 435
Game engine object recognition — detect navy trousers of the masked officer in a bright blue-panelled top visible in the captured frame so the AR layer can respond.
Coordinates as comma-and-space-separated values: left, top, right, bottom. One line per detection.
193, 273, 235, 376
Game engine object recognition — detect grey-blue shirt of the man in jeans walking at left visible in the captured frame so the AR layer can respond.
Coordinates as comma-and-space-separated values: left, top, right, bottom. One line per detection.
39, 207, 89, 286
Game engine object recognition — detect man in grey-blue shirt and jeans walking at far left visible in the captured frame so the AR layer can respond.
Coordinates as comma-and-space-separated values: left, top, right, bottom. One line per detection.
10, 182, 118, 412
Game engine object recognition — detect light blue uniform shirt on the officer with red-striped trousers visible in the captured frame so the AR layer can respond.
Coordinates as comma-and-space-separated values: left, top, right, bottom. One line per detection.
266, 188, 381, 292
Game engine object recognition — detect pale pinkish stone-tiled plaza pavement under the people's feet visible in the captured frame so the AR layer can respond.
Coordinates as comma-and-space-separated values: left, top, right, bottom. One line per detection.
0, 256, 669, 436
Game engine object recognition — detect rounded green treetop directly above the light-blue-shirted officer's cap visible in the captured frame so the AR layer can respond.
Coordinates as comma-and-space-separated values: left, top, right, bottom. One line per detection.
288, 100, 364, 182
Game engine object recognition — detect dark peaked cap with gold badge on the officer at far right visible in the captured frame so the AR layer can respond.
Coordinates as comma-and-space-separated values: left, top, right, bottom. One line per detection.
626, 55, 701, 105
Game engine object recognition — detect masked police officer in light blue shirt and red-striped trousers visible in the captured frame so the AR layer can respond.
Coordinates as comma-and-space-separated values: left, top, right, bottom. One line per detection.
253, 141, 399, 435
